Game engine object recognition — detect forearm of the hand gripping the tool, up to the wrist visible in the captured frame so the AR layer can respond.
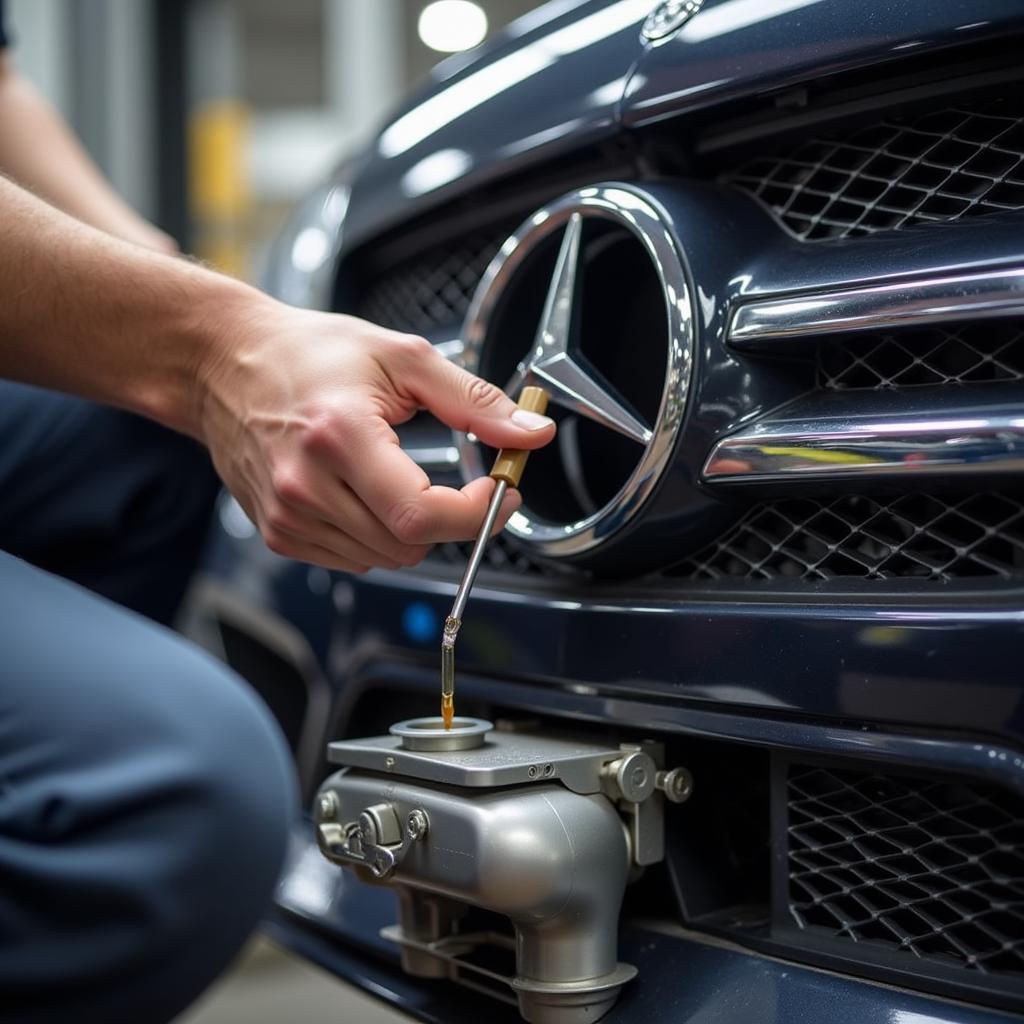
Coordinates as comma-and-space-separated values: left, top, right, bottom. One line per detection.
0, 179, 260, 436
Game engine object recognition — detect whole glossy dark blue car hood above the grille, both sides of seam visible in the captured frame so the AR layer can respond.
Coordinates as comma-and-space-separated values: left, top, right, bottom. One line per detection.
344, 0, 1024, 249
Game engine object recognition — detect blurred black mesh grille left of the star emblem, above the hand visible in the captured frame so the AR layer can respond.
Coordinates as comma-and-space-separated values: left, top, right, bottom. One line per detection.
356, 225, 514, 334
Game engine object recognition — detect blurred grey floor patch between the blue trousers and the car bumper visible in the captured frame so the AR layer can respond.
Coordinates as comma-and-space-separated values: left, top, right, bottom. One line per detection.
175, 939, 409, 1024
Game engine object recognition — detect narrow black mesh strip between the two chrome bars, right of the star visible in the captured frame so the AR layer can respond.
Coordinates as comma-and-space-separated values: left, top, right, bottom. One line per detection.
817, 324, 1024, 391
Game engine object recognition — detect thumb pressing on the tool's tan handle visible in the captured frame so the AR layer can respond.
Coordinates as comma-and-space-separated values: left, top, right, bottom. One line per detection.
416, 354, 555, 449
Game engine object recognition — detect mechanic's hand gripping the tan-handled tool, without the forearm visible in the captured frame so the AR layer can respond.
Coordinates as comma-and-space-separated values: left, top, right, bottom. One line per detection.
201, 302, 555, 572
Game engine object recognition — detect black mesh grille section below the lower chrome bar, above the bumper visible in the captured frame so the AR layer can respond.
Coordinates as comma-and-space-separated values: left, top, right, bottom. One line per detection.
671, 493, 1024, 581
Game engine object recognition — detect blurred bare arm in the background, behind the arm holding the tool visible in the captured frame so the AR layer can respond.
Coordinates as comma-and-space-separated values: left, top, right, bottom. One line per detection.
0, 51, 177, 252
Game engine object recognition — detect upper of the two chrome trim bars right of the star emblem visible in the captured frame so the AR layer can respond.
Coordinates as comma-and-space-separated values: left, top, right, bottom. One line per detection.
728, 267, 1024, 348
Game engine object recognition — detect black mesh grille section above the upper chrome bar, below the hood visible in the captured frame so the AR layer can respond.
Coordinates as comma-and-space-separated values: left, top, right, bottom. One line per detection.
724, 100, 1024, 240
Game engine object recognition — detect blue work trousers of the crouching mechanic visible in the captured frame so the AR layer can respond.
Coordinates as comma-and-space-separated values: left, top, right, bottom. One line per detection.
0, 381, 295, 1024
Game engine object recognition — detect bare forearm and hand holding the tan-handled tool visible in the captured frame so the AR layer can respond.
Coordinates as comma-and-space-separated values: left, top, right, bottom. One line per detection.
0, 179, 554, 571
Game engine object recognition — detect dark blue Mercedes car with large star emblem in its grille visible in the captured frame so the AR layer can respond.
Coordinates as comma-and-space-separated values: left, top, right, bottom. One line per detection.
184, 0, 1024, 1024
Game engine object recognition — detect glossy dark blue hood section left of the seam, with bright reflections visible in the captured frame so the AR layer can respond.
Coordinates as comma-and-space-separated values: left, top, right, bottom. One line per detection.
346, 0, 650, 245
